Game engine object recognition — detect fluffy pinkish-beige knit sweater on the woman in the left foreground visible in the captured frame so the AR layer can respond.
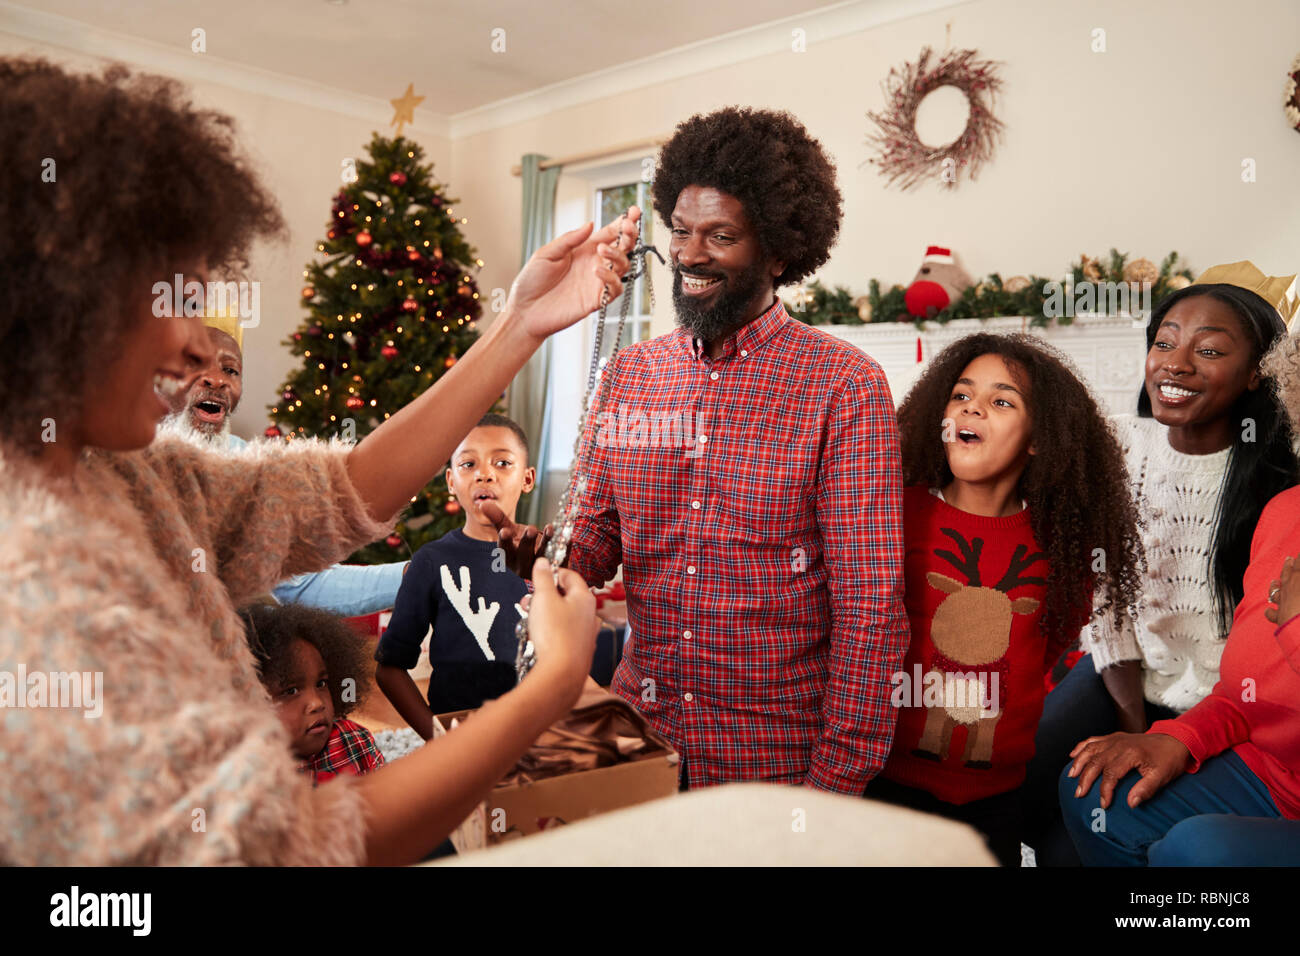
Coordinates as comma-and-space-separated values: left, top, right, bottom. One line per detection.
0, 436, 390, 865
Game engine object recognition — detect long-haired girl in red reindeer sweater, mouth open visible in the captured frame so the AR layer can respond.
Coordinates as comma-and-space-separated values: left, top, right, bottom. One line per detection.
866, 333, 1139, 866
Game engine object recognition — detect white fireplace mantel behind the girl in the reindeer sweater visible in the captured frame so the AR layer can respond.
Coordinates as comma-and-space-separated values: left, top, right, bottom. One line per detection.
815, 315, 1147, 414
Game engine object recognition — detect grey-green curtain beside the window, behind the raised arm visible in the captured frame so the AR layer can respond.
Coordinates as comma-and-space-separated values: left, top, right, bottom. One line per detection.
506, 152, 560, 527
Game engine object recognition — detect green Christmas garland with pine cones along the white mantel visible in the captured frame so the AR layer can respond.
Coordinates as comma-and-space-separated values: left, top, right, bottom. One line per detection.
785, 250, 1192, 329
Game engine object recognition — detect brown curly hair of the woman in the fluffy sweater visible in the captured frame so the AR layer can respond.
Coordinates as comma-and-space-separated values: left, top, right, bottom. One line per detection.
0, 57, 287, 453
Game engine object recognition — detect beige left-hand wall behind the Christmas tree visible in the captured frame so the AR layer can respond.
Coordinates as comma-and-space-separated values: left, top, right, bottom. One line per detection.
0, 33, 451, 437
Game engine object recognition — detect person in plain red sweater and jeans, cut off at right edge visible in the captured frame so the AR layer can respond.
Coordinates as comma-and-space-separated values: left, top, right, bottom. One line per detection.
1060, 327, 1300, 866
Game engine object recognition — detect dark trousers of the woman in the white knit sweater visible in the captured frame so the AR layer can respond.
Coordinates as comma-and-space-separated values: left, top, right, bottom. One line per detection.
1021, 654, 1178, 866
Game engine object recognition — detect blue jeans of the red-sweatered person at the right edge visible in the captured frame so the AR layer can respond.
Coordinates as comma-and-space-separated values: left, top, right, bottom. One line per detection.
1060, 750, 1284, 866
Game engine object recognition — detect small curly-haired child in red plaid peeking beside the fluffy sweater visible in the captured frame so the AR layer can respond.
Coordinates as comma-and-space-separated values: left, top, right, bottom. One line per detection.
239, 604, 384, 783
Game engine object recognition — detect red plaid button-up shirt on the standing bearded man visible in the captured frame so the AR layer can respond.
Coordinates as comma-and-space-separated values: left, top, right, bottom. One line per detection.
571, 299, 909, 793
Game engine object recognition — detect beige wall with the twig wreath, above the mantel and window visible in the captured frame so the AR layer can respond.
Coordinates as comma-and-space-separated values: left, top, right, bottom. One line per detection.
452, 0, 1300, 343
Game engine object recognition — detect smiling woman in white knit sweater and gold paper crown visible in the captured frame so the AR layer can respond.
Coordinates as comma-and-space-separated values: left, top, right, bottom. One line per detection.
1024, 265, 1300, 865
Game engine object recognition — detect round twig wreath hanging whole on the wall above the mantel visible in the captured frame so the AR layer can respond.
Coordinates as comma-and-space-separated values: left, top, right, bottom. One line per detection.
867, 47, 1002, 190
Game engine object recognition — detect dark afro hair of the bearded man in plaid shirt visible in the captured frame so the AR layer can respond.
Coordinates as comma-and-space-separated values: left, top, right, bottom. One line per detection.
651, 107, 844, 287
